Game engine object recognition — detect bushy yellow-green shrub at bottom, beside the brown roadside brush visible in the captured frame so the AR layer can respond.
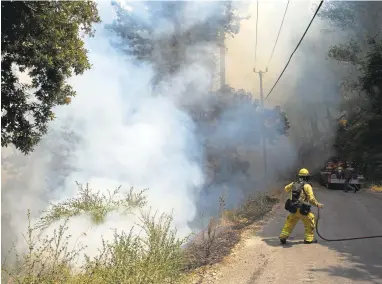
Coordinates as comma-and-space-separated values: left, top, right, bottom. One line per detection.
79, 210, 187, 284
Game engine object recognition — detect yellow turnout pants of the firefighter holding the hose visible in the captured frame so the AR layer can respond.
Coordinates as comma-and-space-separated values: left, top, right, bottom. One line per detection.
280, 209, 315, 242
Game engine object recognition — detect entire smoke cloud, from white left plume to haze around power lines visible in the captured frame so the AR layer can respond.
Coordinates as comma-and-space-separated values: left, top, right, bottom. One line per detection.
2, 1, 346, 262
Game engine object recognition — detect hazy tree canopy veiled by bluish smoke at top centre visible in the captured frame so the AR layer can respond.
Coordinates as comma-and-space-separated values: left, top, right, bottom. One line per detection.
107, 1, 243, 83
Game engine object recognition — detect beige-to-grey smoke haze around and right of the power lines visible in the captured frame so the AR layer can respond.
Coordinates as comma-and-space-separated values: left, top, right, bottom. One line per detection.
226, 0, 349, 176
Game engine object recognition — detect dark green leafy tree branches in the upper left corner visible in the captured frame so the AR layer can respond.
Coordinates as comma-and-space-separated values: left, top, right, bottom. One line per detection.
1, 1, 100, 154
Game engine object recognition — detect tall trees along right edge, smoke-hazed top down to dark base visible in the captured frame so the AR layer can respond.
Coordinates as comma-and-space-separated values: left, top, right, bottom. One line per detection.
321, 2, 382, 178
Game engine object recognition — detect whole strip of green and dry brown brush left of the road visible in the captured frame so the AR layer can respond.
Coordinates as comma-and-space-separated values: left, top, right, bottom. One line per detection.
2, 184, 274, 284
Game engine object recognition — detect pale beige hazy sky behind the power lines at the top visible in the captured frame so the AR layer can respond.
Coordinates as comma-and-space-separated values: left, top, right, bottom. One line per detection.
226, 0, 319, 106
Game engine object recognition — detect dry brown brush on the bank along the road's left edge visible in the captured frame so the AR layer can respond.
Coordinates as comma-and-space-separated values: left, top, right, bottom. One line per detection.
186, 193, 280, 284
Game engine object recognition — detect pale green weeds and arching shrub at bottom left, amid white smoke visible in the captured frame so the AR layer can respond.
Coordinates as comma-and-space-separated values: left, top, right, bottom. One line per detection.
2, 184, 187, 284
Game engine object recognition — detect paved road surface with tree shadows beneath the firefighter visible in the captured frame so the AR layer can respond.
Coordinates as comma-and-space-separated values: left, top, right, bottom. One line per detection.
208, 188, 382, 284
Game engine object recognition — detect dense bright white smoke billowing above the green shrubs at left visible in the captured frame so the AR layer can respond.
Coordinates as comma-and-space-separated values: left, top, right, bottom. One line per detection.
3, 0, 204, 262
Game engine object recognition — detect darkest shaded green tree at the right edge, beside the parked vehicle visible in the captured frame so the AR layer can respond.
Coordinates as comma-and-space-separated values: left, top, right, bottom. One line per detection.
335, 40, 382, 177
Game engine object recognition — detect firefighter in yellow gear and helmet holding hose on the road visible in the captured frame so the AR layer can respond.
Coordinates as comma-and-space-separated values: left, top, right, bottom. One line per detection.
280, 169, 324, 244
